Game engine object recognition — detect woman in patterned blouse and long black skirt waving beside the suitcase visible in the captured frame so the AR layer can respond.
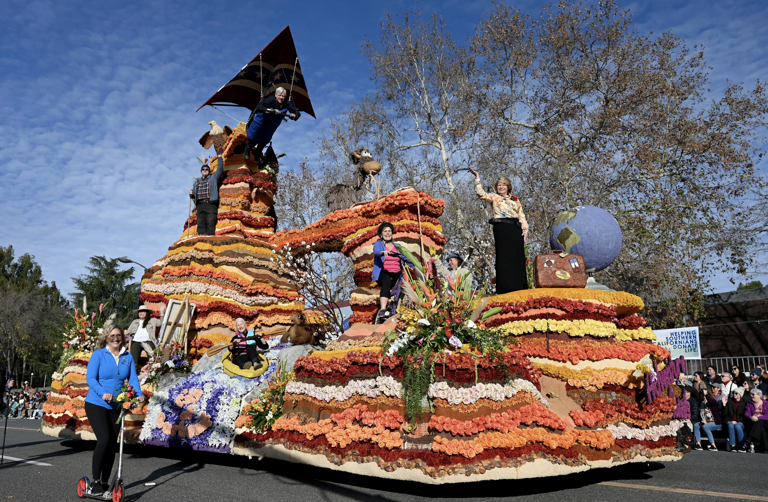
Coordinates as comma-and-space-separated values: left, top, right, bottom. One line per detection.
469, 168, 528, 295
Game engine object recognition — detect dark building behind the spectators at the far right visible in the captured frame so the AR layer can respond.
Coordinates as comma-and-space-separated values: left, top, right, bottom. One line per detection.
699, 287, 768, 358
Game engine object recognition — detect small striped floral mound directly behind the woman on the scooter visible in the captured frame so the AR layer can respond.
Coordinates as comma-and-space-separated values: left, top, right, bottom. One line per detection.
42, 352, 152, 440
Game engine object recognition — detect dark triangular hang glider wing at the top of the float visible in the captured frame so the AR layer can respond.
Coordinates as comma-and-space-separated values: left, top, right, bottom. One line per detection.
197, 26, 317, 118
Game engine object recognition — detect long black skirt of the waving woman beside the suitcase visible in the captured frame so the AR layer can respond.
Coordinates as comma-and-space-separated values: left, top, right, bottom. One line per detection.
491, 218, 528, 295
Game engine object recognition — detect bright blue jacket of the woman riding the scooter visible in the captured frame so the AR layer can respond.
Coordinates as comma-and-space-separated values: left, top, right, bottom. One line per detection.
85, 347, 144, 409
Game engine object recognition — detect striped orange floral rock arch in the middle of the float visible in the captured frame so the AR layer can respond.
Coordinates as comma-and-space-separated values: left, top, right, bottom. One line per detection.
271, 188, 446, 325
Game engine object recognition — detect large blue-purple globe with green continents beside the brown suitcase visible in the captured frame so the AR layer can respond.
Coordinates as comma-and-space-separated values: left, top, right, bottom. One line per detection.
549, 206, 622, 272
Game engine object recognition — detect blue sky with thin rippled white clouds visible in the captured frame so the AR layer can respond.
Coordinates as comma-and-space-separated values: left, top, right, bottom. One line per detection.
0, 0, 768, 293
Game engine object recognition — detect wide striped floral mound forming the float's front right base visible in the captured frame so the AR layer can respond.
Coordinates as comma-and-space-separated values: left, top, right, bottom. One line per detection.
234, 289, 690, 483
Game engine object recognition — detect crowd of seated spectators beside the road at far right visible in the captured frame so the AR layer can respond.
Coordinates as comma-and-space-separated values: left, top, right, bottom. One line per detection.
678, 366, 768, 453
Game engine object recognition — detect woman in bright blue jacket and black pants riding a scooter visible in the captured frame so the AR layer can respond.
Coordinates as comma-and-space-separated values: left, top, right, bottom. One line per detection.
85, 325, 144, 495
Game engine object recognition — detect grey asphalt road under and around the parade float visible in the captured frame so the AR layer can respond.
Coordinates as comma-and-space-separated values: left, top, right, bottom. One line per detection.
0, 419, 768, 502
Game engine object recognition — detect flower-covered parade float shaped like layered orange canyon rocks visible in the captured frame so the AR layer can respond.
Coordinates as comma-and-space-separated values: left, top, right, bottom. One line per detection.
42, 26, 690, 484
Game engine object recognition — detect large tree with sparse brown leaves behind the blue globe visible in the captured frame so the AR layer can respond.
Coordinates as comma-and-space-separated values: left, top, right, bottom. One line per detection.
473, 0, 768, 324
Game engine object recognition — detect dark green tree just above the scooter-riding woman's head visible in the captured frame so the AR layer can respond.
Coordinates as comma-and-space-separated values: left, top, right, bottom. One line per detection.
70, 256, 140, 328
